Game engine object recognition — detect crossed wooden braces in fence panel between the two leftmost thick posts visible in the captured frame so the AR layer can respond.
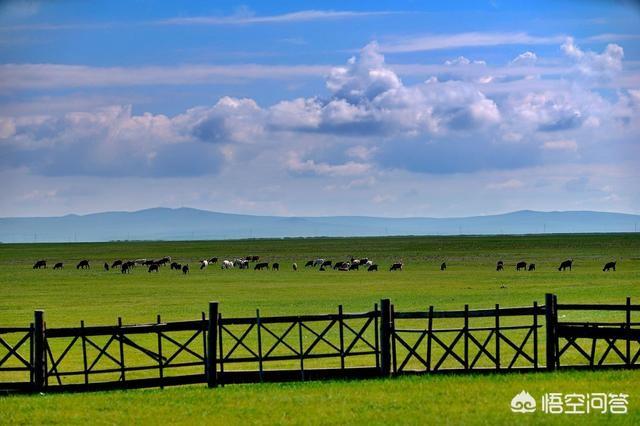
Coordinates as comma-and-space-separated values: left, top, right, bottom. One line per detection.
45, 330, 205, 385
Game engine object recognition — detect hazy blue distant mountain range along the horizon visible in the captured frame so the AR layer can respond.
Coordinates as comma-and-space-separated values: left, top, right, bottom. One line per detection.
0, 208, 640, 243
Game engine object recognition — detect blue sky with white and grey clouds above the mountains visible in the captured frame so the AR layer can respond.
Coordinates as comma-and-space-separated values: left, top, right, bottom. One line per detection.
0, 0, 640, 217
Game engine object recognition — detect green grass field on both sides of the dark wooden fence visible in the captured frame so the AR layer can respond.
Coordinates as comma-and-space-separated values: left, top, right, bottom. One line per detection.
0, 234, 640, 424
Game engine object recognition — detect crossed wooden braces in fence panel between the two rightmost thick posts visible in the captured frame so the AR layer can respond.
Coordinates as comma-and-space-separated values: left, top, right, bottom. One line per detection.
393, 325, 537, 372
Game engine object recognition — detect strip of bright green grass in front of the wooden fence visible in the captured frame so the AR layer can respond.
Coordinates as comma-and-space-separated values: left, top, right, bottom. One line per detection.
0, 371, 640, 425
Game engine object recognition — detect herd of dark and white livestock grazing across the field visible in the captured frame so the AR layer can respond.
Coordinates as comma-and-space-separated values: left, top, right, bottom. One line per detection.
27, 256, 616, 275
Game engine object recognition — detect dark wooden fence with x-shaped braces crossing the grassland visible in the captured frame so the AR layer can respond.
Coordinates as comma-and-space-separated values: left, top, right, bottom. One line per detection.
0, 294, 640, 393
